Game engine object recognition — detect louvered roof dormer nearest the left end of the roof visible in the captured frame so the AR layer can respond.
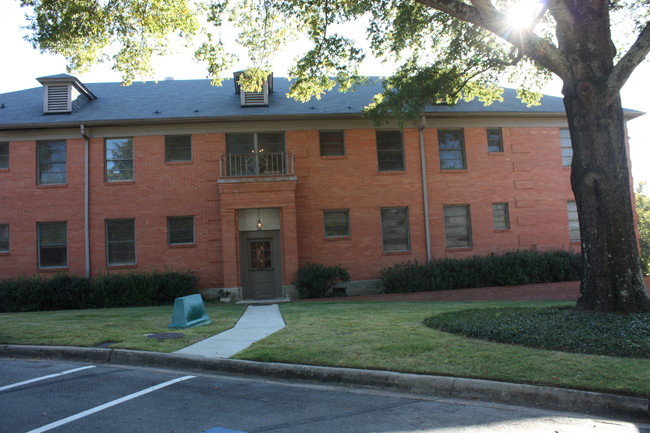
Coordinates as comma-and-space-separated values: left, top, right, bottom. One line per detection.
37, 74, 97, 114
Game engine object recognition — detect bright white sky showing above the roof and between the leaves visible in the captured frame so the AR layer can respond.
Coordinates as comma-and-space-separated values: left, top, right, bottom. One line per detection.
0, 0, 650, 186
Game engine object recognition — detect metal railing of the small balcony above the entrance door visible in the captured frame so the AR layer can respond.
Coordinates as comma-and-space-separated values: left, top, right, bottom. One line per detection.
219, 153, 293, 177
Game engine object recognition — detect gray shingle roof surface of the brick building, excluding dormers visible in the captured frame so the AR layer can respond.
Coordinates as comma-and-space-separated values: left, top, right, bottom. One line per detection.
0, 75, 641, 129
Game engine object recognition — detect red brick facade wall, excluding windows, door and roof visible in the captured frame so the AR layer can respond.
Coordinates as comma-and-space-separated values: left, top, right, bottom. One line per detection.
0, 128, 612, 287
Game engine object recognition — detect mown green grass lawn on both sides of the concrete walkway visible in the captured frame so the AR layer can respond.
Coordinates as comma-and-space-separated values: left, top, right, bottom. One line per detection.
0, 302, 650, 397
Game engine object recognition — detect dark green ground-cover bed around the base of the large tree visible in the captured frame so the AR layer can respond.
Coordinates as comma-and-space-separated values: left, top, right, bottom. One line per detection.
424, 307, 650, 358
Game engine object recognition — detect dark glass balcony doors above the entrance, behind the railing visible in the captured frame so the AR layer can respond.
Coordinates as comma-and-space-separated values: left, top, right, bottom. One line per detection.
226, 132, 286, 176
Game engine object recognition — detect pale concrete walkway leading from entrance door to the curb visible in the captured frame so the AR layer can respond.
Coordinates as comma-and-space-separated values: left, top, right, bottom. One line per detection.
174, 304, 285, 358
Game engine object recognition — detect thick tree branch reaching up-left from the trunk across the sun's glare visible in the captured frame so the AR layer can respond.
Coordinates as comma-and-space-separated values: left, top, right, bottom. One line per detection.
415, 0, 570, 78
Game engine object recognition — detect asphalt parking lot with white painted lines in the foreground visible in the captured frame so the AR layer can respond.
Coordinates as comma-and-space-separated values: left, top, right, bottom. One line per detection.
0, 359, 650, 433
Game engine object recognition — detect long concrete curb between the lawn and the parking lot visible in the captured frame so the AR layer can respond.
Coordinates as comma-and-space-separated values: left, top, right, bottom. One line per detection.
0, 344, 650, 422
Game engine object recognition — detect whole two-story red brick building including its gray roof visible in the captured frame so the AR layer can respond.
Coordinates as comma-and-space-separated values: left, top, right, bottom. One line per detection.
0, 74, 641, 298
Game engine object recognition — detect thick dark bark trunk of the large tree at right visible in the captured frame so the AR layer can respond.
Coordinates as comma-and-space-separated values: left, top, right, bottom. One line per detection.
563, 80, 650, 312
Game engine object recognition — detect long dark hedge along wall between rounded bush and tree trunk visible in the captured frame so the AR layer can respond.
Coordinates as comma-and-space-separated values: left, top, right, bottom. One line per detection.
381, 250, 582, 293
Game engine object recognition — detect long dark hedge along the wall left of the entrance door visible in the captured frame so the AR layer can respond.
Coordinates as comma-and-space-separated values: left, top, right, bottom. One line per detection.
0, 272, 197, 313
